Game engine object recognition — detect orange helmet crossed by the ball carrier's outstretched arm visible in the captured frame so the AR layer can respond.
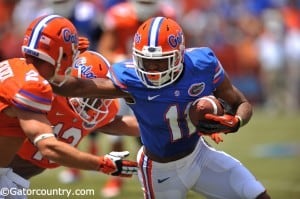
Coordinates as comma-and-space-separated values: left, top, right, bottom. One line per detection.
69, 51, 112, 126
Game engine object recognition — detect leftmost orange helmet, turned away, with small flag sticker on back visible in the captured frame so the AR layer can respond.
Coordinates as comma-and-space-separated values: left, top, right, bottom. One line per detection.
22, 15, 78, 86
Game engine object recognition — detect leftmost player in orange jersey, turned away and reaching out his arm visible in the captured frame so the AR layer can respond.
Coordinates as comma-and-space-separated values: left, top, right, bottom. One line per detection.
0, 15, 136, 197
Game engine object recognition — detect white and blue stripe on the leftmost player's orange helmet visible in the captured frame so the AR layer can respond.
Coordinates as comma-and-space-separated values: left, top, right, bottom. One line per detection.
28, 15, 61, 48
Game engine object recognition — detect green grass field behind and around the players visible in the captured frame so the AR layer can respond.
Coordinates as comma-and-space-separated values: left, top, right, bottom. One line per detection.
29, 109, 300, 199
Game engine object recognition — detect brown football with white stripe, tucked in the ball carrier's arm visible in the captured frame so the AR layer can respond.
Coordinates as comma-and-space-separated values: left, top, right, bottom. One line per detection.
189, 95, 224, 126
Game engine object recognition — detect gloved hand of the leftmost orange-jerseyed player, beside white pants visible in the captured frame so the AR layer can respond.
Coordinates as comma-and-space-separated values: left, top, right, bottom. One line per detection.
99, 151, 138, 177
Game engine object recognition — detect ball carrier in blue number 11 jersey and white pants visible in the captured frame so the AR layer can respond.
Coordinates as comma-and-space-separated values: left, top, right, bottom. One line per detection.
55, 17, 270, 199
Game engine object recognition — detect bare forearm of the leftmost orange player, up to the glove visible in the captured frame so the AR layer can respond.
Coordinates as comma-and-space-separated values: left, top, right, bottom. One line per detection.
37, 138, 99, 171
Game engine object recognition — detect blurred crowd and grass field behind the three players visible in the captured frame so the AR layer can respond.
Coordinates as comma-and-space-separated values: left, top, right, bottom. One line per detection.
0, 0, 300, 199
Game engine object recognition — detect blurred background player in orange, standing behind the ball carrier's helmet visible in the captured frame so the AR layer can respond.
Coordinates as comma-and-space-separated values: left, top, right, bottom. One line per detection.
98, 0, 175, 197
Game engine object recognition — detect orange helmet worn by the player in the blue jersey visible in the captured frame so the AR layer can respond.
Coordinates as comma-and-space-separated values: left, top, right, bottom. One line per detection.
133, 17, 185, 88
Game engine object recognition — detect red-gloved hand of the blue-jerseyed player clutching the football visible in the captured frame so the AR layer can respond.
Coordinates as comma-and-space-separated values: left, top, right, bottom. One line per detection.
197, 114, 240, 134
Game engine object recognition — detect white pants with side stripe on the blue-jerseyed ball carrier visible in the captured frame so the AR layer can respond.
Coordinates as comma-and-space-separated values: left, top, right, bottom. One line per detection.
137, 137, 265, 199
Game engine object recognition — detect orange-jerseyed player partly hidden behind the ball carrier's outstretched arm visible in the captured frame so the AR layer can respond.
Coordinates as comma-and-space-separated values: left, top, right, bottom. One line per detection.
10, 51, 139, 179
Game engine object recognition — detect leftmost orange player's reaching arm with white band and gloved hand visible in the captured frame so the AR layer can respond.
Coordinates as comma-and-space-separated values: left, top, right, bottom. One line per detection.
16, 109, 137, 177
